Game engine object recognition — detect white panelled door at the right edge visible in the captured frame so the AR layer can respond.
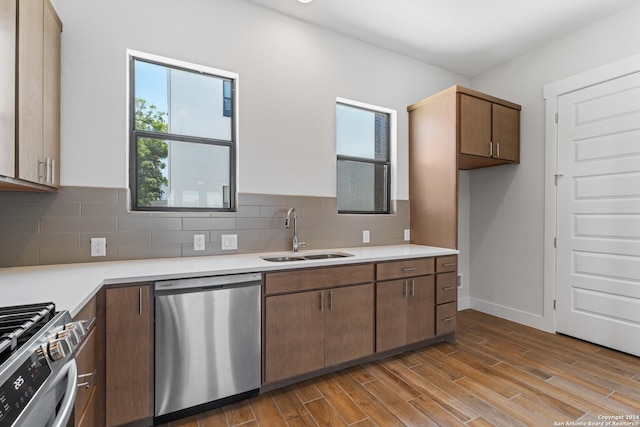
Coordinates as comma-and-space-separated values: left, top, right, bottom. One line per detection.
556, 73, 640, 356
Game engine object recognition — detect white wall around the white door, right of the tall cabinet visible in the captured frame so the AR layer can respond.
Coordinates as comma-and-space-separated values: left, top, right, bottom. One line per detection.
470, 0, 640, 330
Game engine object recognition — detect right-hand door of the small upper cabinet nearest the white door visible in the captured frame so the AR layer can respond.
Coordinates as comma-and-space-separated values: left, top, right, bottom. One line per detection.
492, 104, 520, 162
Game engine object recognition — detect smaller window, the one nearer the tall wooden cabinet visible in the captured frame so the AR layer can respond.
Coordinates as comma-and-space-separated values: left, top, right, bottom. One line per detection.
336, 99, 395, 214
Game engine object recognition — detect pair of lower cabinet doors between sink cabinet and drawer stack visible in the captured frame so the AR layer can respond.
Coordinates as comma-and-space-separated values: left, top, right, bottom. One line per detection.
376, 276, 435, 352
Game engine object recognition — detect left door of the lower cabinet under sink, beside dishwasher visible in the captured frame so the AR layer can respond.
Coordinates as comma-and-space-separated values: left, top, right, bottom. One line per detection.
264, 291, 327, 383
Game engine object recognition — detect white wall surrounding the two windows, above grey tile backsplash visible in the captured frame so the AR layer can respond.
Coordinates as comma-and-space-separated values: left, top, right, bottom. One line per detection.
53, 0, 468, 200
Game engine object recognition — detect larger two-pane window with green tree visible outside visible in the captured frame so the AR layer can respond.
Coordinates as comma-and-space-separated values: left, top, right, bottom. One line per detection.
129, 52, 237, 211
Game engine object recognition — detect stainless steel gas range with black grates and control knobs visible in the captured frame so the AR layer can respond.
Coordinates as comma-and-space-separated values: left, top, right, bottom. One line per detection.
0, 303, 95, 427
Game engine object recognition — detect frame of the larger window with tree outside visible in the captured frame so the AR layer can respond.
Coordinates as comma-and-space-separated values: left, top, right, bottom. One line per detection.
127, 49, 239, 212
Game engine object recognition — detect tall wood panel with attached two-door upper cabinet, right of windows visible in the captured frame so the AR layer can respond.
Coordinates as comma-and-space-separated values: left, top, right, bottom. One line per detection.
407, 86, 521, 249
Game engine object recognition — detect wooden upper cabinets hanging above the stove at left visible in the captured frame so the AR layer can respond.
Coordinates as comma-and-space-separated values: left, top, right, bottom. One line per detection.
0, 0, 62, 191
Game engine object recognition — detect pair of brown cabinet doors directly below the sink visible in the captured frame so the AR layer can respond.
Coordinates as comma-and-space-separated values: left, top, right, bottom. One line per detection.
264, 283, 374, 383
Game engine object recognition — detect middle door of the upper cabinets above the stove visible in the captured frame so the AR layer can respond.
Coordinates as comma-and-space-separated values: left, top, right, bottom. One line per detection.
18, 0, 44, 183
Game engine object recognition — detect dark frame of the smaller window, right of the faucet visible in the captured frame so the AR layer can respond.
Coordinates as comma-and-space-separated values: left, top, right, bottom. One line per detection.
335, 97, 397, 215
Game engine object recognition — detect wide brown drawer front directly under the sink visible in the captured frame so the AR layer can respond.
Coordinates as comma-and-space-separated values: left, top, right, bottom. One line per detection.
264, 264, 373, 295
